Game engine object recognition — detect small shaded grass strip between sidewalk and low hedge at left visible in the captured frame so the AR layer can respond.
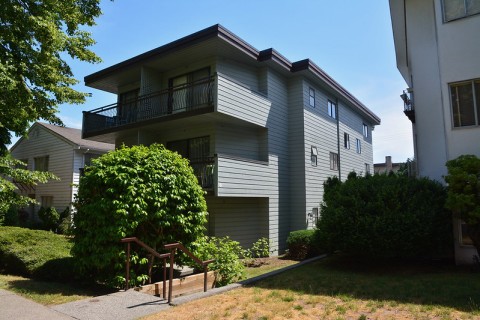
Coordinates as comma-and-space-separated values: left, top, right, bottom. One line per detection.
0, 274, 112, 305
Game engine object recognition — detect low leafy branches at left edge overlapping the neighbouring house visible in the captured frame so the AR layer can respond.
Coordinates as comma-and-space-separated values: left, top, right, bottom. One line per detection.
0, 154, 57, 225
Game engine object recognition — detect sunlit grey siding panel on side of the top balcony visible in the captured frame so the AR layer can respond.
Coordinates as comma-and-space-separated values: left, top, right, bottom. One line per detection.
217, 74, 270, 127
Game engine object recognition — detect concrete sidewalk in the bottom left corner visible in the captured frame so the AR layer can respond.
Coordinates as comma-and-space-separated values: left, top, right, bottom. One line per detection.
0, 289, 75, 320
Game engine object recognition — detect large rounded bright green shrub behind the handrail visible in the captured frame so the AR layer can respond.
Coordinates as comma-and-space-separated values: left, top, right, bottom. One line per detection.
72, 144, 207, 286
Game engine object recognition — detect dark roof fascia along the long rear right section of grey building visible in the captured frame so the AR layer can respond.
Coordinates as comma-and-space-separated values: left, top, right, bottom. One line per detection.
291, 59, 381, 125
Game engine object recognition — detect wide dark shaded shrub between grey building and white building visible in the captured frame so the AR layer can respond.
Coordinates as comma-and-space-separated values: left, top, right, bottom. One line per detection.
317, 175, 452, 258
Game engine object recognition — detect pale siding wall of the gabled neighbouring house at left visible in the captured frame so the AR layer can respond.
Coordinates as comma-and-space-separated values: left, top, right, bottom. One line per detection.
12, 125, 74, 211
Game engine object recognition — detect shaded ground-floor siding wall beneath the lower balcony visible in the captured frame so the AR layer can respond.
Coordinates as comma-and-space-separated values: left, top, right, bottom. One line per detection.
206, 197, 268, 248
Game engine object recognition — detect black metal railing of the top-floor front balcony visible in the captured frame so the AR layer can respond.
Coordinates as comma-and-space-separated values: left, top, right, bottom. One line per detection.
83, 76, 215, 136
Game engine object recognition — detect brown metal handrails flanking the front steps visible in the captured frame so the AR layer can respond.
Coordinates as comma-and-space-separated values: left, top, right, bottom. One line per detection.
120, 237, 215, 303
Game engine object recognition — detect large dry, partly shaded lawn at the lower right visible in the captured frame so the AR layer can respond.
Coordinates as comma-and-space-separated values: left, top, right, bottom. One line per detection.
145, 256, 480, 320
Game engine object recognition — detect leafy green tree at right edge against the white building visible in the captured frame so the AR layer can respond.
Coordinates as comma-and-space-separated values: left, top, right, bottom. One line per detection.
445, 155, 480, 252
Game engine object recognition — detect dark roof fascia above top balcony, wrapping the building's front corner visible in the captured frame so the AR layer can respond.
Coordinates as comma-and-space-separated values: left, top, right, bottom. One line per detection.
84, 24, 259, 85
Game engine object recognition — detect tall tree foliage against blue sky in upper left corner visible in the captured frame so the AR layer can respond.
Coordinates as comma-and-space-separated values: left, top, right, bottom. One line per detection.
0, 0, 101, 151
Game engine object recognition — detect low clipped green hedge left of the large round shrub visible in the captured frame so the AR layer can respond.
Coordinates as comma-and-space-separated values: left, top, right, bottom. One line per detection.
0, 227, 73, 280
